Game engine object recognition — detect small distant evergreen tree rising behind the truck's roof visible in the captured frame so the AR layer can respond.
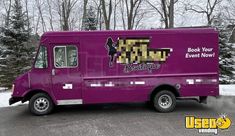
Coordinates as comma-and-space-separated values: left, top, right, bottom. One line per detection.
84, 6, 97, 30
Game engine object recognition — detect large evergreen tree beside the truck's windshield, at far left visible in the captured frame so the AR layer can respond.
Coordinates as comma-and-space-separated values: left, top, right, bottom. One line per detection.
0, 0, 34, 87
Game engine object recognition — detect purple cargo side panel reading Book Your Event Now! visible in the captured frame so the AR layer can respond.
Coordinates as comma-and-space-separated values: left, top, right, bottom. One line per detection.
81, 32, 219, 103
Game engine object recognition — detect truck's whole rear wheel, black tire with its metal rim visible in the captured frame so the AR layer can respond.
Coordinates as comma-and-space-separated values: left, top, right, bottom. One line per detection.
152, 90, 176, 113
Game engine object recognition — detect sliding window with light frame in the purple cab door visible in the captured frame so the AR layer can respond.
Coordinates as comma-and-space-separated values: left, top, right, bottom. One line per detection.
54, 45, 78, 68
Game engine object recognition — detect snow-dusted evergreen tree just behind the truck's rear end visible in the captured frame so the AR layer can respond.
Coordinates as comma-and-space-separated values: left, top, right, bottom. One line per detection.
213, 17, 235, 84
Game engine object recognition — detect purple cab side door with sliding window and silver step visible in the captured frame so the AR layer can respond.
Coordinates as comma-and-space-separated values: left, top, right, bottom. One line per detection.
51, 44, 82, 105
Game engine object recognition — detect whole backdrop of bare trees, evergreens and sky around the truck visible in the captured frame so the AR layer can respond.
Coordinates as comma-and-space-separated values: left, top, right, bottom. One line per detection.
0, 0, 235, 87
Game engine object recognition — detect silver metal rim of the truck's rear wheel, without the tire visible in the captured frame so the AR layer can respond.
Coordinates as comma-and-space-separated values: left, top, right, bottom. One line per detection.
158, 94, 172, 109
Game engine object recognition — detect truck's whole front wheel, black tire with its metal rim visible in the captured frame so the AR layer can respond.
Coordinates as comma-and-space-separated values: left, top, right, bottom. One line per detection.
29, 93, 54, 116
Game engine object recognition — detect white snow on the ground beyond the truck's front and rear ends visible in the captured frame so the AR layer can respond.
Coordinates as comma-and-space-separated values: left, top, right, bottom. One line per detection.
0, 84, 235, 107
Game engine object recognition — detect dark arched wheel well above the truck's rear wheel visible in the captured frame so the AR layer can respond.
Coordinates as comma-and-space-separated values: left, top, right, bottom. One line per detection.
150, 84, 180, 101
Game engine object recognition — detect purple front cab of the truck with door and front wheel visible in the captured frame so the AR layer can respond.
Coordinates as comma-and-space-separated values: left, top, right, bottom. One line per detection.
9, 33, 82, 114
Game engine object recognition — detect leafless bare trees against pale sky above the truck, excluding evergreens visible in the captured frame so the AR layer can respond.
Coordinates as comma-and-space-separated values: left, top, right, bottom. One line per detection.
0, 0, 235, 31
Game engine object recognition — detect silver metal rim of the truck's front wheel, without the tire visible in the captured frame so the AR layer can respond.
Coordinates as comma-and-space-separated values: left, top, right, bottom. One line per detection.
34, 97, 49, 112
